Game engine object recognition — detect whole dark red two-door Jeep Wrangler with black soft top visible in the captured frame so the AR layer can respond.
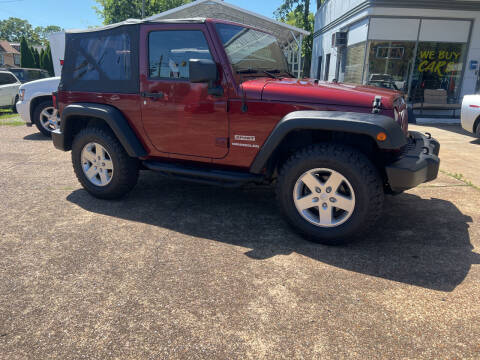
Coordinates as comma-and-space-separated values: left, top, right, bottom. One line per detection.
53, 19, 440, 244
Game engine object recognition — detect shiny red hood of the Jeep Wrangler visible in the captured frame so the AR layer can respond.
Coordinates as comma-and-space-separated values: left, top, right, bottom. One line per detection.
242, 78, 401, 109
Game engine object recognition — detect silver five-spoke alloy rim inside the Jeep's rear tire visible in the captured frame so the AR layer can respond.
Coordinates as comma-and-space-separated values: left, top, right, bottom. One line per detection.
80, 142, 113, 186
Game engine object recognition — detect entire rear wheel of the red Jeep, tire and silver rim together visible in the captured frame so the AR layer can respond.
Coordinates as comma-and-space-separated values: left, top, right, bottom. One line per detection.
72, 127, 139, 199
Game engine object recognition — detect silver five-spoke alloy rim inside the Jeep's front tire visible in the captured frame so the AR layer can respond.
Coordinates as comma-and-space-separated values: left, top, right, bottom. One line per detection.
293, 168, 355, 227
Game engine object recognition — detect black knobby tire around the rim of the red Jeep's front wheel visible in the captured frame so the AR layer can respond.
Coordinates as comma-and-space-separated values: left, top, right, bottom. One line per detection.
276, 143, 384, 245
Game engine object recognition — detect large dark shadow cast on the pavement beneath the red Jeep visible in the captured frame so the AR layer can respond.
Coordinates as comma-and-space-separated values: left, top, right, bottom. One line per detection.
67, 173, 480, 291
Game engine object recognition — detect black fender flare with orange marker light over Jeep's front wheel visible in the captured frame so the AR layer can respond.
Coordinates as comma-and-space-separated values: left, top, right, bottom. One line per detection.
250, 111, 407, 174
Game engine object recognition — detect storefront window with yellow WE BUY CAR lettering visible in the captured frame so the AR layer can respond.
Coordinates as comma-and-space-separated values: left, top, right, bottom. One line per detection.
410, 42, 467, 104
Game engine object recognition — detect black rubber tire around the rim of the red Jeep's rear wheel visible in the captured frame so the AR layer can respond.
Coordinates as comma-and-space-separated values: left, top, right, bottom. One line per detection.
72, 127, 139, 199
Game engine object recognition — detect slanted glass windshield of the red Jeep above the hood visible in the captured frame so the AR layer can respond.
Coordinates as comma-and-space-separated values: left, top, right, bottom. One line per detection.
215, 23, 292, 77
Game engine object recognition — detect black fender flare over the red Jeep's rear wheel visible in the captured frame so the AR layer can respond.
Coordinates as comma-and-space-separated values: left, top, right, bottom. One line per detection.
52, 103, 147, 157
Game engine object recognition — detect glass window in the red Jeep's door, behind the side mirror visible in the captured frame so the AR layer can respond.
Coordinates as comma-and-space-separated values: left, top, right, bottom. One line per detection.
148, 30, 213, 80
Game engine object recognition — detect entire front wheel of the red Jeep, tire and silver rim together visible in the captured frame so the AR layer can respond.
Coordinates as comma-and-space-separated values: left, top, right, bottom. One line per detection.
276, 144, 384, 245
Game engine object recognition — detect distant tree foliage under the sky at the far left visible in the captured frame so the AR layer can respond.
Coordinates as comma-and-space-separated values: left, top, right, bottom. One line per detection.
0, 17, 62, 45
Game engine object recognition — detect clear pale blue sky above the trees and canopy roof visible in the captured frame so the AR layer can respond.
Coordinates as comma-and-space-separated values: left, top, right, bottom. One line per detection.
0, 0, 315, 29
